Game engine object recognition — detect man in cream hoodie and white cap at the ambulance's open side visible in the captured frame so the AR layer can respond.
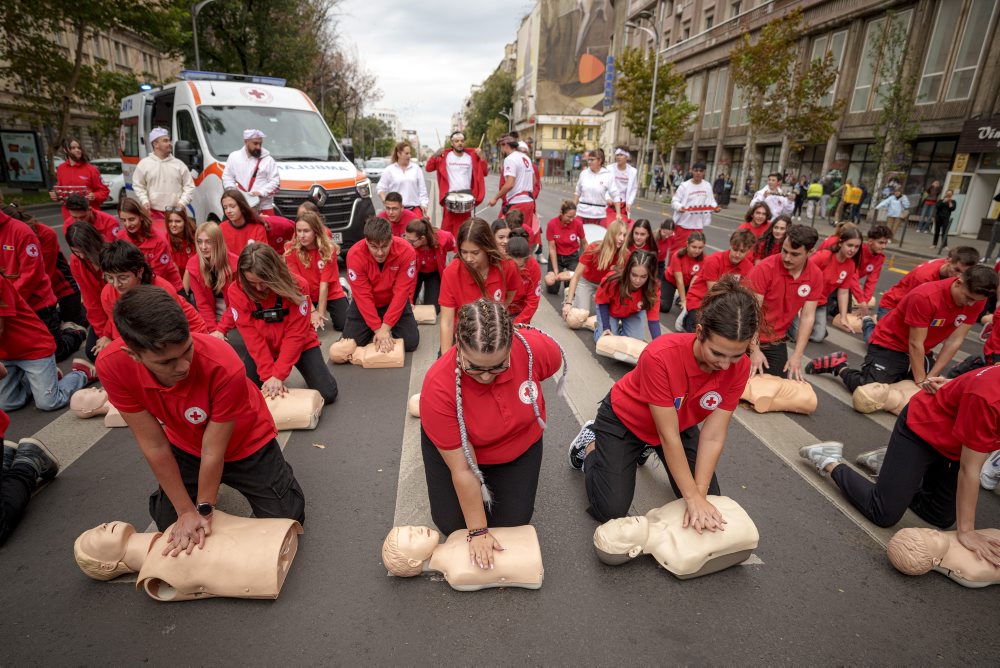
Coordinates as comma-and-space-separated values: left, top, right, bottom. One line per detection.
131, 128, 195, 234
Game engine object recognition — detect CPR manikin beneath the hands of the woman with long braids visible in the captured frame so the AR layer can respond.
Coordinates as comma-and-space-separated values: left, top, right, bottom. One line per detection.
382, 525, 545, 591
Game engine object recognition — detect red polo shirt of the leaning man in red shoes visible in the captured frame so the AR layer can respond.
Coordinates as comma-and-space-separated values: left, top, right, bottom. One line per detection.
871, 276, 983, 354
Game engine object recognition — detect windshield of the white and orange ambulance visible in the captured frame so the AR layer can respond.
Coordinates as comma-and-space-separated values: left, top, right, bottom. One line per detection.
198, 106, 344, 162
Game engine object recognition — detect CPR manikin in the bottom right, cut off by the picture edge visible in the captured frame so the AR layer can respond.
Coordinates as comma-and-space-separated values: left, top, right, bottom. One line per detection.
886, 528, 1000, 587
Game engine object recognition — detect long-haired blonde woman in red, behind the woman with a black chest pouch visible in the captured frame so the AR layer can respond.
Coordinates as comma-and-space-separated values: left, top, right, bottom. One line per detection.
185, 221, 239, 339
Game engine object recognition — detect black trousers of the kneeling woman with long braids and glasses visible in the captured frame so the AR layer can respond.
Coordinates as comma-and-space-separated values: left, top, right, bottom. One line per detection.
420, 428, 542, 536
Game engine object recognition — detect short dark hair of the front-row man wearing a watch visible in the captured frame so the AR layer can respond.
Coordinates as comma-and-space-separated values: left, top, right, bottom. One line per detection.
114, 285, 191, 352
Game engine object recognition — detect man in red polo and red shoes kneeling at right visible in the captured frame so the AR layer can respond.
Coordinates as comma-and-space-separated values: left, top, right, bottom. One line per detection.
807, 265, 997, 392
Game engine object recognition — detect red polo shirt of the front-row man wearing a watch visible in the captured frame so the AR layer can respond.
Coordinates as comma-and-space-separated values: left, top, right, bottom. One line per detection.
97, 334, 278, 462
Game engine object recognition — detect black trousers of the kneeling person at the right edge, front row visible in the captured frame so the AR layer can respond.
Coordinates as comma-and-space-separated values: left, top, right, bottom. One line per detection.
830, 406, 959, 529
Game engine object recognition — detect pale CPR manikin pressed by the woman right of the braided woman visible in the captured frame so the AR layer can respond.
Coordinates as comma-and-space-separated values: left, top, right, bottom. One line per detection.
594, 496, 760, 580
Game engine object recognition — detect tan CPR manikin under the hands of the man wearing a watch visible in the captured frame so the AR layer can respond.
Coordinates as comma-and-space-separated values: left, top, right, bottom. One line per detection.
73, 510, 302, 601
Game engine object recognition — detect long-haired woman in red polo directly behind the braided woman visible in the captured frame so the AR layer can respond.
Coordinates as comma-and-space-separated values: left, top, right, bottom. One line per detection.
439, 218, 521, 353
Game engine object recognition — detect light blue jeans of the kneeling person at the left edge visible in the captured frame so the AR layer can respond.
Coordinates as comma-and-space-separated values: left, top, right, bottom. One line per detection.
0, 355, 87, 411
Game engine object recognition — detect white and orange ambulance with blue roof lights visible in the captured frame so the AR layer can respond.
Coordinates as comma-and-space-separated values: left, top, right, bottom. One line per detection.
119, 70, 375, 253
